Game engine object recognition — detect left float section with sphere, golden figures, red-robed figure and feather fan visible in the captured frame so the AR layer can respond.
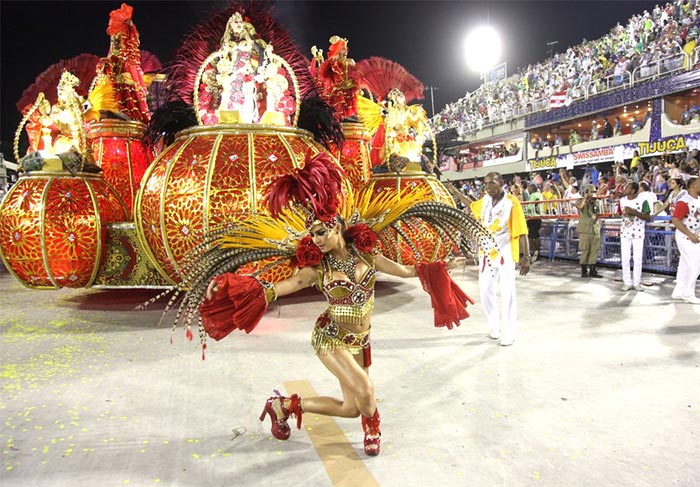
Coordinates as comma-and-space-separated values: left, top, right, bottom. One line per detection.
0, 4, 165, 289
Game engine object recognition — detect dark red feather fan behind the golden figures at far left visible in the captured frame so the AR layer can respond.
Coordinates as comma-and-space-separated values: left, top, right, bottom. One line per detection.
16, 53, 100, 113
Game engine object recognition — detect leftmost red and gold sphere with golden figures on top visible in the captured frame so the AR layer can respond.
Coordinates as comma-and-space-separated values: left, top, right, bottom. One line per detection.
0, 71, 128, 289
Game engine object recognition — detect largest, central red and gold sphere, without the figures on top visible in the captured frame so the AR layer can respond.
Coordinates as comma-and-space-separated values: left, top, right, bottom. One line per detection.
134, 124, 334, 283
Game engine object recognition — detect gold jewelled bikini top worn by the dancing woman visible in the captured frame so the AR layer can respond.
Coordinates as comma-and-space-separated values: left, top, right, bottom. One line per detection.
319, 256, 377, 326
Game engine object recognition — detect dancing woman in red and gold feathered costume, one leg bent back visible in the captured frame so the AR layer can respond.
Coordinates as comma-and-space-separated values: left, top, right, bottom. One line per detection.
179, 154, 498, 455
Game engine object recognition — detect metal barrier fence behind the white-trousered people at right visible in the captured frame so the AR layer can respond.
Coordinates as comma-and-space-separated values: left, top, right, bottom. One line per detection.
539, 216, 679, 274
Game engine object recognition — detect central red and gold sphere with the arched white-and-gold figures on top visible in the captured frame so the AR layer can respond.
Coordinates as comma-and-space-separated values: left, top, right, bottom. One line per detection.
135, 12, 344, 284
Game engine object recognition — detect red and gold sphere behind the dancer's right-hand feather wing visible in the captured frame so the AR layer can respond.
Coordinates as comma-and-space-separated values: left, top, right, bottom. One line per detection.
370, 171, 454, 265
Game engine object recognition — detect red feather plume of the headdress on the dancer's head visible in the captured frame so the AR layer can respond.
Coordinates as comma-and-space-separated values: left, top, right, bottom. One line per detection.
264, 152, 343, 221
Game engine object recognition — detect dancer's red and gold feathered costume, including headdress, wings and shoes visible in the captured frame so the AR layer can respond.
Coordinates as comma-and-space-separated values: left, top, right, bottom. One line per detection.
154, 149, 498, 455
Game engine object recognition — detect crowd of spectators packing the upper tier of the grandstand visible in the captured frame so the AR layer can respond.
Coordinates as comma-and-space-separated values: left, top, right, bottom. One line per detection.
432, 0, 700, 137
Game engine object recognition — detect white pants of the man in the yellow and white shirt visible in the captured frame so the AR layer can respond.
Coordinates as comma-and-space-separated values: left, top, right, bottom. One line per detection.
479, 255, 518, 338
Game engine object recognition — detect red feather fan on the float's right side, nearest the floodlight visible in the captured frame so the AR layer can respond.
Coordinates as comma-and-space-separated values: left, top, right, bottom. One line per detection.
355, 56, 423, 103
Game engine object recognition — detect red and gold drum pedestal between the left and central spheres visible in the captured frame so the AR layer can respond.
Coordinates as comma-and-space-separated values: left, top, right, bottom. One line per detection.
87, 120, 153, 220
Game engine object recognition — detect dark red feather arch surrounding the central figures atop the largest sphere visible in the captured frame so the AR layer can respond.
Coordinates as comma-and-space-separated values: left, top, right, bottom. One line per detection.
166, 1, 315, 105
